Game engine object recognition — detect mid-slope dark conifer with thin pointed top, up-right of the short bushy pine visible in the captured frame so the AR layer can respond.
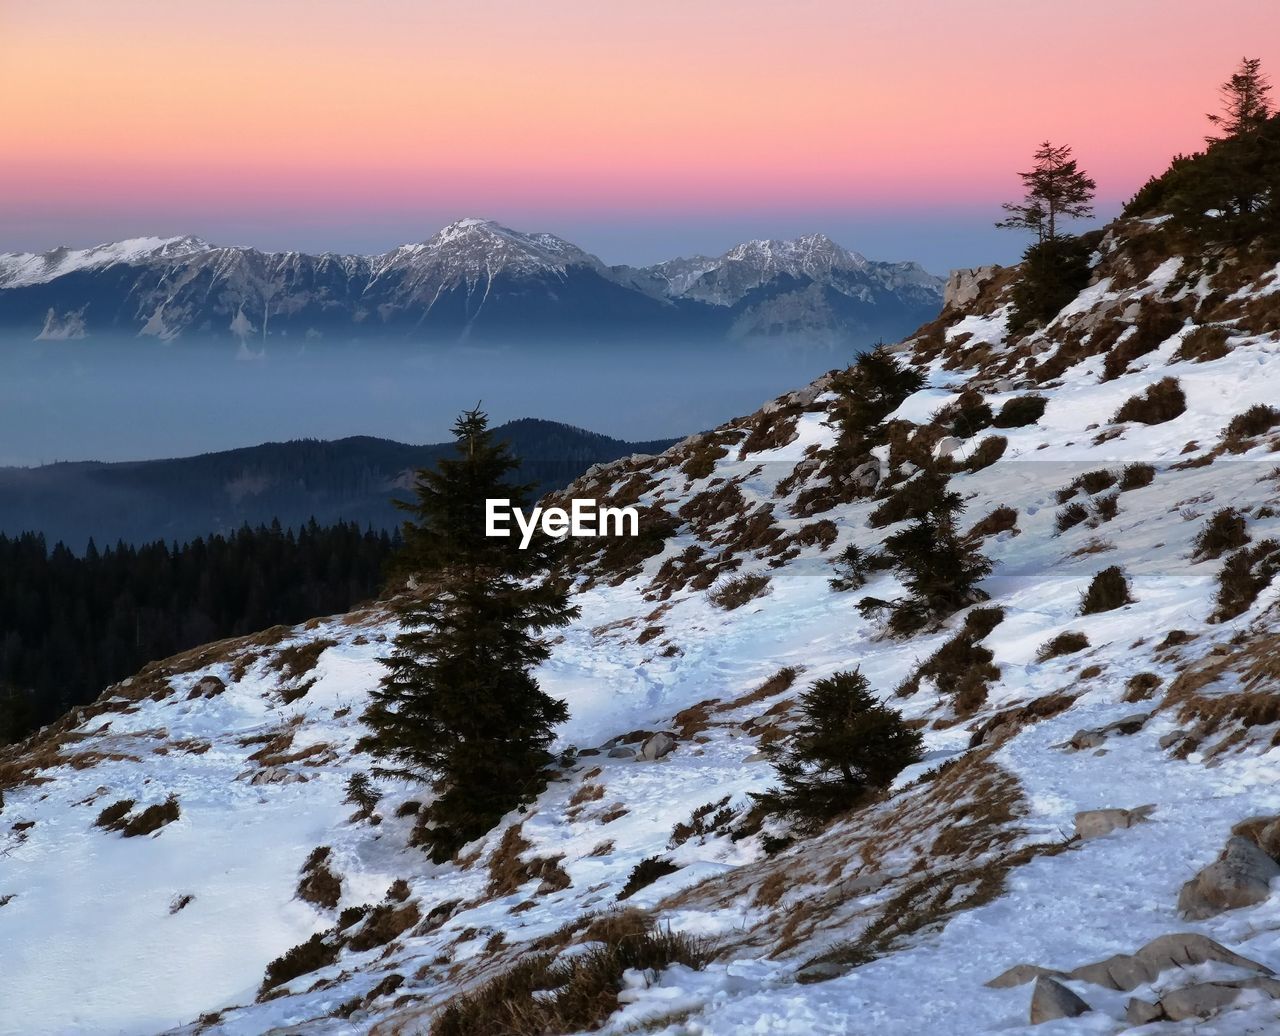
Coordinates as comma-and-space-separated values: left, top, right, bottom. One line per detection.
884, 473, 991, 635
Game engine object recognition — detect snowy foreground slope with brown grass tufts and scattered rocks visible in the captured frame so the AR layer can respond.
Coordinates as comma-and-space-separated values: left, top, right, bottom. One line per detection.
0, 213, 1280, 1036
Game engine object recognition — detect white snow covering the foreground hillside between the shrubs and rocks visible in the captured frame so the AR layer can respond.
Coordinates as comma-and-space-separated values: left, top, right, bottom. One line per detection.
0, 231, 1280, 1036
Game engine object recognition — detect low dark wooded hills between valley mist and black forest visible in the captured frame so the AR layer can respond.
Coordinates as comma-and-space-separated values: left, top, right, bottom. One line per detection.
0, 417, 675, 551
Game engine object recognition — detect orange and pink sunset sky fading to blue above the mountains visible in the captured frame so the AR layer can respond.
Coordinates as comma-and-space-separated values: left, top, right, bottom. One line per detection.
0, 0, 1280, 271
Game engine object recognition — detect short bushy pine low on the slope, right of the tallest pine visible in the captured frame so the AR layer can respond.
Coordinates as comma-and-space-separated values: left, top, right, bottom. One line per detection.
756, 670, 922, 827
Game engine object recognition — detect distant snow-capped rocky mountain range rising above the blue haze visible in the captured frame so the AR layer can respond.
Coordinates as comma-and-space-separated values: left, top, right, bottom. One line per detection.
0, 219, 942, 346
